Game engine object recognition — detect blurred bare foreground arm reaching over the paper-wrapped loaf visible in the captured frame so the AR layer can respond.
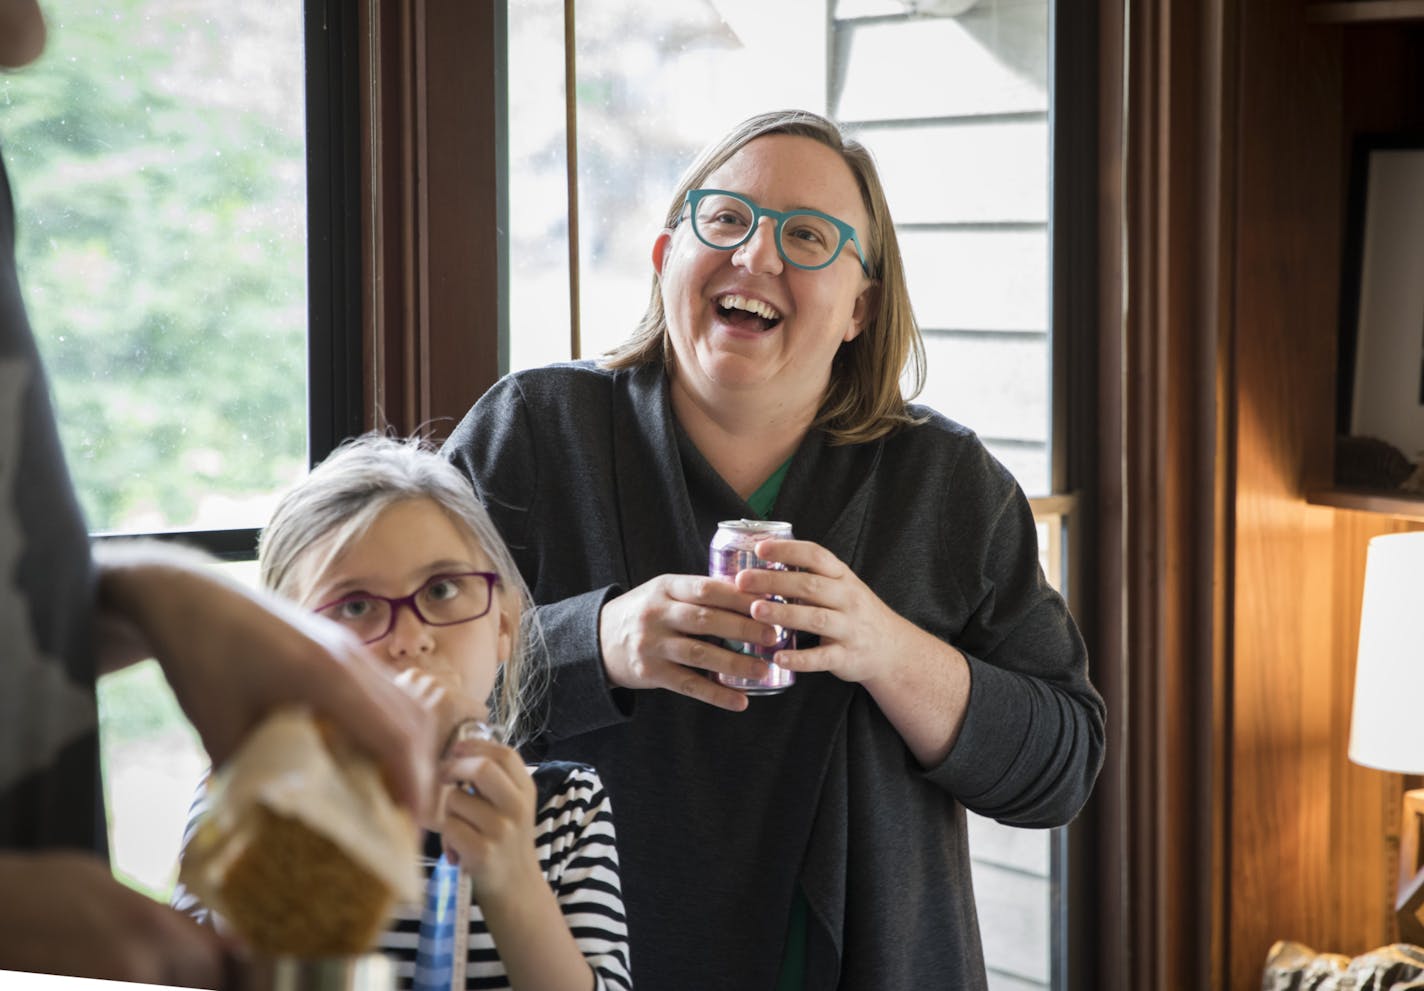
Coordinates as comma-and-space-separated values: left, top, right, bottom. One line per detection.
95, 541, 436, 816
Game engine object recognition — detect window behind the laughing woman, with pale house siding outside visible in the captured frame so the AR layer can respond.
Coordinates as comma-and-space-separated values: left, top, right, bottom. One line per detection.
508, 0, 1075, 991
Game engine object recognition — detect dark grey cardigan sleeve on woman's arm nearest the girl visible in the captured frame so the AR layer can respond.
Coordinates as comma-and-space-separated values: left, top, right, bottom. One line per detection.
441, 376, 631, 739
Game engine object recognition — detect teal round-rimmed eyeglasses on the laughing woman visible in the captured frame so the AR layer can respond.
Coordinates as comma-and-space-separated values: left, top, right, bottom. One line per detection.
678, 189, 874, 279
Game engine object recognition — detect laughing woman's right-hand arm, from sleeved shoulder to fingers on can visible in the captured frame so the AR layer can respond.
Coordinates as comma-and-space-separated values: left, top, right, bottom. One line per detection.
738, 447, 1105, 826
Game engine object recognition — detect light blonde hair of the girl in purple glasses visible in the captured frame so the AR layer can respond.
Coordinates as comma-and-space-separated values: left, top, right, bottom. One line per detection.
258, 433, 548, 746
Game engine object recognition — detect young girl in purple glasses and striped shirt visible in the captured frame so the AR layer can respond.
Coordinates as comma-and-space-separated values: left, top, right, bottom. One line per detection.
174, 434, 631, 991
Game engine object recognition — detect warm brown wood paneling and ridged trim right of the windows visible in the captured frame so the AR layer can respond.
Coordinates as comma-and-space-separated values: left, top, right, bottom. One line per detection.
1116, 0, 1424, 991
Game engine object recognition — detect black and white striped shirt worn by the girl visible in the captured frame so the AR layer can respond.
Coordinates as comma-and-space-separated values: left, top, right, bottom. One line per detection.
172, 762, 632, 991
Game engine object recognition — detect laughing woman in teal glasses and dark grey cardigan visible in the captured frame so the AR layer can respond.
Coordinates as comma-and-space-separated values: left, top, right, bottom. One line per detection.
446, 111, 1104, 990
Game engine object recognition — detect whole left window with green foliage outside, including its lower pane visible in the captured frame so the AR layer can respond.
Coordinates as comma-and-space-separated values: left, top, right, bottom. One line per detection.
0, 0, 360, 898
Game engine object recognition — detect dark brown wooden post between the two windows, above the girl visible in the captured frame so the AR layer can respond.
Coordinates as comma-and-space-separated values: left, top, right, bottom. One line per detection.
362, 0, 503, 439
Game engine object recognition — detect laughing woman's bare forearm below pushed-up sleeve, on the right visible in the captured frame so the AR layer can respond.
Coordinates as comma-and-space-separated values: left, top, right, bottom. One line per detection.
863, 619, 970, 767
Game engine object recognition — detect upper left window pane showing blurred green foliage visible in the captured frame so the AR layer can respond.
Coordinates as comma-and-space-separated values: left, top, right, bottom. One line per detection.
0, 0, 308, 531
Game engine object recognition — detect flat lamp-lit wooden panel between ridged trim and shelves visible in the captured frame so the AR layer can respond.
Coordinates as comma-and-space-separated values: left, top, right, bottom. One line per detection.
1229, 0, 1354, 988
